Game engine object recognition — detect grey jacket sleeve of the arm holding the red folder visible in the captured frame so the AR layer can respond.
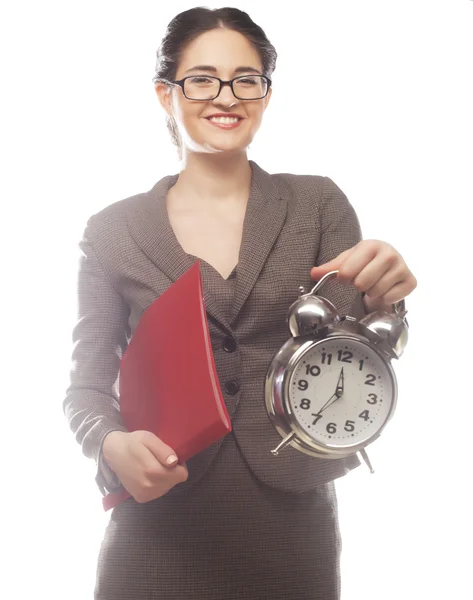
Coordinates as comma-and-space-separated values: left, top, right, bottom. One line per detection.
63, 220, 129, 494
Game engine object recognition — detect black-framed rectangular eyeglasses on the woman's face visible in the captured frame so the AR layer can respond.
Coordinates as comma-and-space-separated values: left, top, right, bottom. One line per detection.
163, 75, 271, 101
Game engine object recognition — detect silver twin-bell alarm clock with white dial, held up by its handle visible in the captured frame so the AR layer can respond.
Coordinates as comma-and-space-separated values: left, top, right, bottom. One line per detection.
265, 271, 409, 472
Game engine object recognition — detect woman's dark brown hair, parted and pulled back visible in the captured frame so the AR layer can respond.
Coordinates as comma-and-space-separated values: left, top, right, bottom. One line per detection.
153, 7, 277, 155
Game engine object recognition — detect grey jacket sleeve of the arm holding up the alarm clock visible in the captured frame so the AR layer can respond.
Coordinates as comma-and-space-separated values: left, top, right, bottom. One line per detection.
315, 177, 367, 319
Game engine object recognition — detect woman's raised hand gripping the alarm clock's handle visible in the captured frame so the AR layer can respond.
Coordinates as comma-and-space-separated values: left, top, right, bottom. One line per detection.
310, 240, 417, 312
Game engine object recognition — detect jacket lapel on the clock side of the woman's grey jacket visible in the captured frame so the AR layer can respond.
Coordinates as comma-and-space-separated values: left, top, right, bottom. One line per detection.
231, 161, 287, 323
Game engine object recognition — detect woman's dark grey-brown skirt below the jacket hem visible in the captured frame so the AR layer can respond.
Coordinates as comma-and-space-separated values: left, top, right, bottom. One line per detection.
95, 434, 341, 600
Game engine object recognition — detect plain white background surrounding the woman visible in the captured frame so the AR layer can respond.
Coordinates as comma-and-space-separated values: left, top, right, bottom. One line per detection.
0, 0, 473, 600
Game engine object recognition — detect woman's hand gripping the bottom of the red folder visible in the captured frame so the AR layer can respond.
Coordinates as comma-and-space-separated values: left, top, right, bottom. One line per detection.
102, 431, 188, 503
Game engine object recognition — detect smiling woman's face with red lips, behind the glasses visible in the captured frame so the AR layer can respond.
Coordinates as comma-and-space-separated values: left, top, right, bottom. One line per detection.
156, 29, 271, 154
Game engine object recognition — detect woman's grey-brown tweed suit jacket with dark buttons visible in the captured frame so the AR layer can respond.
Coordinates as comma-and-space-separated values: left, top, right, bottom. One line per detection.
64, 161, 365, 493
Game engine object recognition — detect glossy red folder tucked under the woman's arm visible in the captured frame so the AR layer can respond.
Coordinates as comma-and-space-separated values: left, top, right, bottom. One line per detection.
102, 260, 231, 510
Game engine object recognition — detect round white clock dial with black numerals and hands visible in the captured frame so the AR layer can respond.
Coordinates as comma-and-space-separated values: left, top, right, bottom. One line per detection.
289, 338, 394, 448
